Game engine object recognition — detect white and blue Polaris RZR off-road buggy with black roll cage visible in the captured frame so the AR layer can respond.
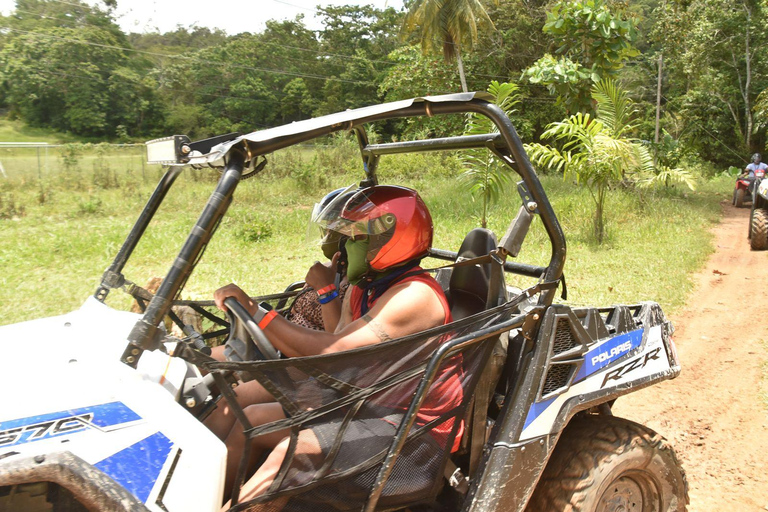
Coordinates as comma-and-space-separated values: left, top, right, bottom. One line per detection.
0, 93, 688, 512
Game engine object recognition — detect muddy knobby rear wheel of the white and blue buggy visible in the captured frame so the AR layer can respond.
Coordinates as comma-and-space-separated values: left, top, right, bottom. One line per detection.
526, 415, 688, 512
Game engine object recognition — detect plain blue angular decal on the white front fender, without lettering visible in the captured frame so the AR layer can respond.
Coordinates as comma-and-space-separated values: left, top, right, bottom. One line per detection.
94, 432, 173, 503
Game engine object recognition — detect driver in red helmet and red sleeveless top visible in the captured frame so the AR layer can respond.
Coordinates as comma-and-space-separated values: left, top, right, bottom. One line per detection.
214, 186, 462, 501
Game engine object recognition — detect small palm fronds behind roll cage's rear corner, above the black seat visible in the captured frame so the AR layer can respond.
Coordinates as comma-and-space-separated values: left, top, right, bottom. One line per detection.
460, 80, 521, 228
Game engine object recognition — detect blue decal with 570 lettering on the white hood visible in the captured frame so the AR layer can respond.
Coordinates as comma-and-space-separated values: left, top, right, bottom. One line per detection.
0, 402, 142, 447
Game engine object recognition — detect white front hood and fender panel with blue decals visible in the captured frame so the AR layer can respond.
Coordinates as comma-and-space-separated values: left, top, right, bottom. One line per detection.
0, 297, 226, 512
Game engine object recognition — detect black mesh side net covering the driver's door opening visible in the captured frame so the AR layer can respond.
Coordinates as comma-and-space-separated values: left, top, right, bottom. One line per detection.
203, 308, 511, 512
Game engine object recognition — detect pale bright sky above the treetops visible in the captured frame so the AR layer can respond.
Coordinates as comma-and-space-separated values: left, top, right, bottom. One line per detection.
0, 0, 403, 35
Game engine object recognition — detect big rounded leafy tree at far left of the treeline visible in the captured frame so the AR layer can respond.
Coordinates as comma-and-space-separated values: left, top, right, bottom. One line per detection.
0, 0, 161, 137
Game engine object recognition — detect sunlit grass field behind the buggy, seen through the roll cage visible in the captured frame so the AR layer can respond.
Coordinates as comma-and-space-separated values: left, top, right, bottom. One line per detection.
0, 138, 731, 324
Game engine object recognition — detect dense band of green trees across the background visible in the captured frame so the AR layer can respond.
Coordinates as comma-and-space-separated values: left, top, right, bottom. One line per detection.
0, 0, 768, 166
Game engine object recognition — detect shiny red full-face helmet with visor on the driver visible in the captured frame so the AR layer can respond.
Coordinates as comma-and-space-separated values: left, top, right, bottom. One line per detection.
328, 185, 433, 272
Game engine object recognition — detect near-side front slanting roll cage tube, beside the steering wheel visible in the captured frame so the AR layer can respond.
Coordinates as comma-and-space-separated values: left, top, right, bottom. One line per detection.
121, 146, 245, 368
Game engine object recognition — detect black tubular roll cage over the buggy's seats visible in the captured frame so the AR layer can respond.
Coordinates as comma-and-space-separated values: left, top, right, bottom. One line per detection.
94, 93, 566, 368
